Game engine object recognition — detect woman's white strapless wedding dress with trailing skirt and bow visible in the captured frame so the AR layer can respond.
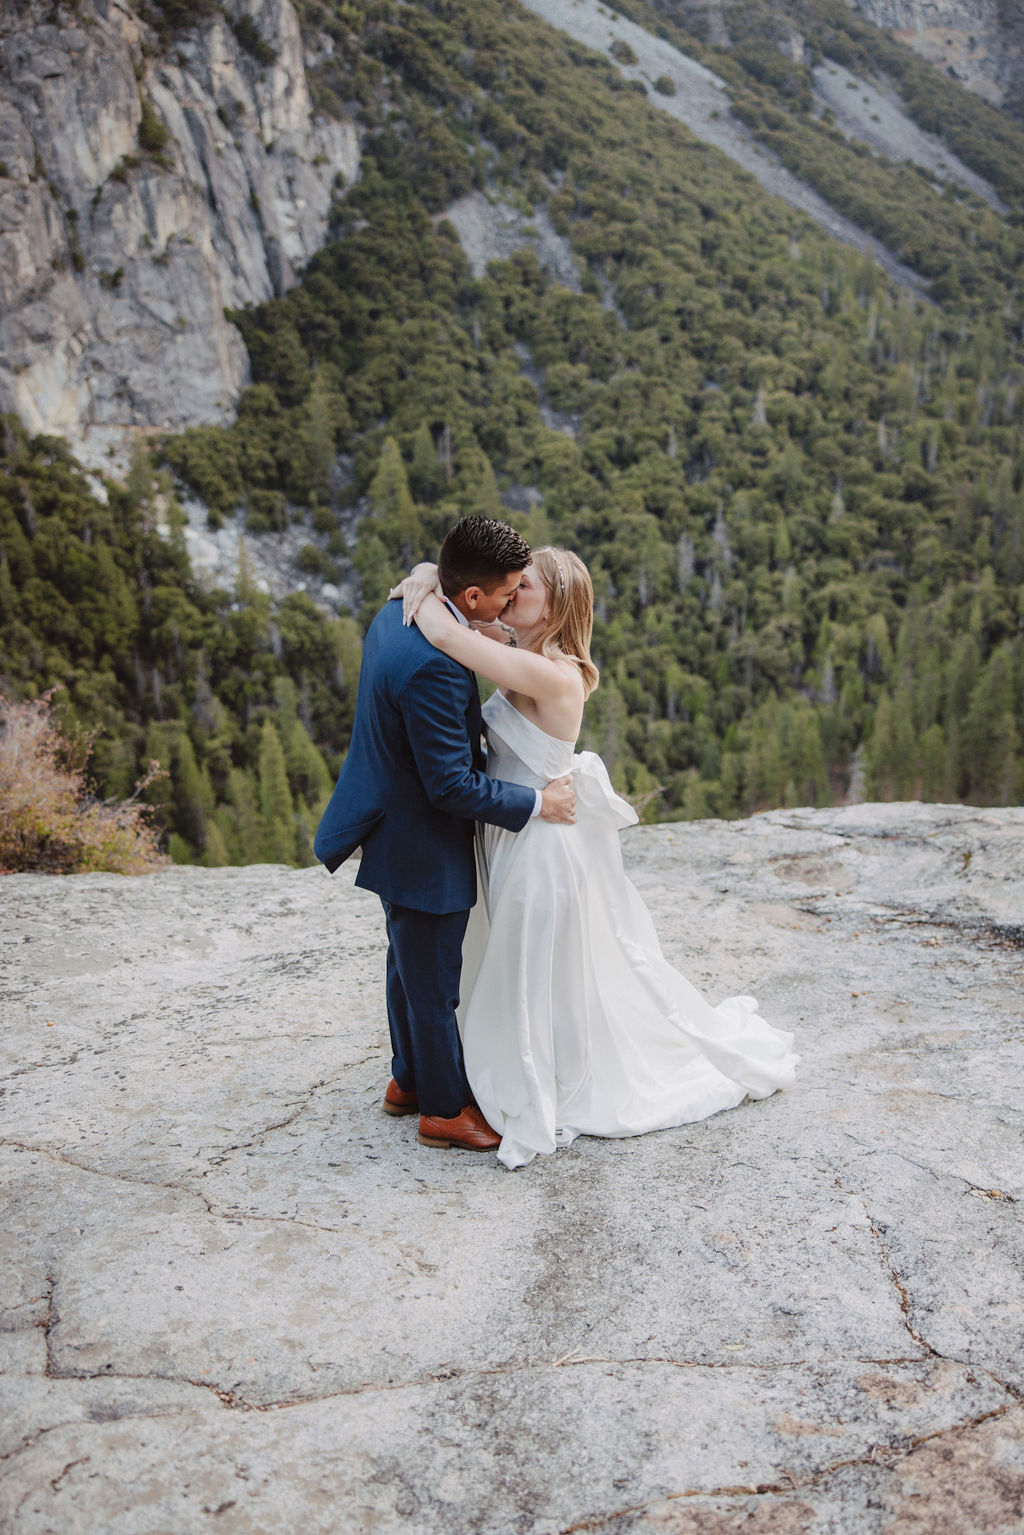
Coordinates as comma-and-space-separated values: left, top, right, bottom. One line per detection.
459, 692, 800, 1168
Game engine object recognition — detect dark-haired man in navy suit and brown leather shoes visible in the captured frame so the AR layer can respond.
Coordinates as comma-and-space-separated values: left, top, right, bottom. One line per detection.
313, 517, 574, 1151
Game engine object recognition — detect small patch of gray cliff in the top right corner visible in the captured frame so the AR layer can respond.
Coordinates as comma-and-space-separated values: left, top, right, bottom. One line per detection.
846, 0, 1024, 109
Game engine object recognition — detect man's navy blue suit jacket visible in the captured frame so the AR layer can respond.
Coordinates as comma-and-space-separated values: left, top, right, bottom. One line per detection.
313, 602, 536, 913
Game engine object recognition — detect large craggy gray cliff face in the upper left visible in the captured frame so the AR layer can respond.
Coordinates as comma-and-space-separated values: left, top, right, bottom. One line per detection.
0, 0, 359, 462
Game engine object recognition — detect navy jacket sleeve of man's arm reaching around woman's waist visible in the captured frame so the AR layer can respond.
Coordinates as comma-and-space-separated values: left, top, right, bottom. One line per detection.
399, 666, 537, 832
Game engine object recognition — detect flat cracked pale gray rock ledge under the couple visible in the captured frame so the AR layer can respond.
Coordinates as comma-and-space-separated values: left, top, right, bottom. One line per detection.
0, 804, 1024, 1535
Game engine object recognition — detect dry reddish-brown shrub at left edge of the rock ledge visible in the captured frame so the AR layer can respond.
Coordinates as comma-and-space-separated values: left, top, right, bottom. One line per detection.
0, 692, 167, 873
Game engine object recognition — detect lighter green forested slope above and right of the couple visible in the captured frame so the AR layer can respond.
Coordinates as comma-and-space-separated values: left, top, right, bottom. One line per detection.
161, 5, 1024, 814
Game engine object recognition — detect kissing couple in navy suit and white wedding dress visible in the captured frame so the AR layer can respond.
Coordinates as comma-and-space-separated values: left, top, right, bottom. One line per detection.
315, 516, 798, 1168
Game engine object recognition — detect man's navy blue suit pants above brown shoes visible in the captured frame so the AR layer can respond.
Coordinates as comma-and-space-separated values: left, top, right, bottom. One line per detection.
381, 900, 473, 1119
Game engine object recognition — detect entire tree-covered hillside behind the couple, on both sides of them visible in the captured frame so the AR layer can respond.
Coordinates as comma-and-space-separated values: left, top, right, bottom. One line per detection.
0, 0, 1024, 863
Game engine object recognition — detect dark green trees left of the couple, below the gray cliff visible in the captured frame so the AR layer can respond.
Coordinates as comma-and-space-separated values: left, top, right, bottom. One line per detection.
0, 418, 359, 864
